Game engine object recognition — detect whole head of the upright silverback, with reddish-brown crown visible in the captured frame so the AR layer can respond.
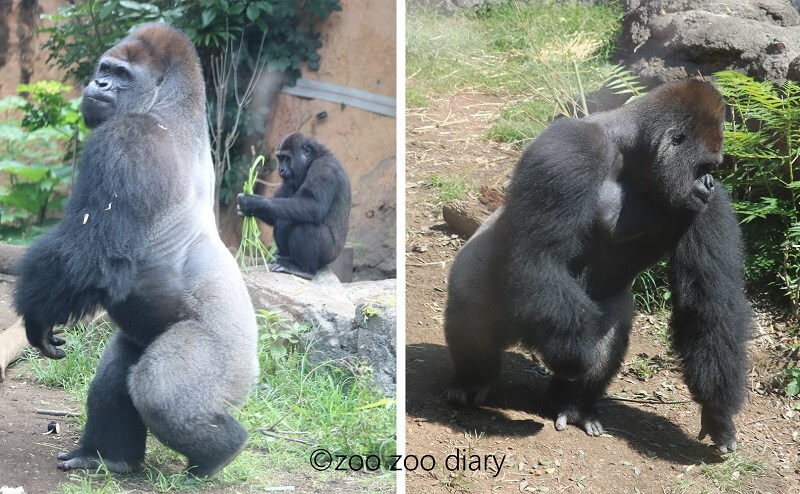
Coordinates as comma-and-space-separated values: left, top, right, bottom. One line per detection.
81, 23, 205, 128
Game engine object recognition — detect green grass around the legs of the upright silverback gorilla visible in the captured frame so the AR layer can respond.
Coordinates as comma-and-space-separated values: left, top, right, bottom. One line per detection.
26, 312, 397, 493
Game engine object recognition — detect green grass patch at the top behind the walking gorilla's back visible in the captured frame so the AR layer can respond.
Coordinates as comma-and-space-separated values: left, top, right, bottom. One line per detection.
406, 1, 622, 146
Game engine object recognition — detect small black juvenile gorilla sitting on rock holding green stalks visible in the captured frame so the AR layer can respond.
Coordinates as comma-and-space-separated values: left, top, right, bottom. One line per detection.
236, 133, 350, 279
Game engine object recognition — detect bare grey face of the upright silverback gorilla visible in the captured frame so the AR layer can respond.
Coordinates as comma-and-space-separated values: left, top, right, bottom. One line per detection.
81, 49, 160, 128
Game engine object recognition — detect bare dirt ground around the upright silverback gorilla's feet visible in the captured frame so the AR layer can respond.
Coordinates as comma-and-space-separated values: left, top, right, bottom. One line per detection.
0, 275, 385, 494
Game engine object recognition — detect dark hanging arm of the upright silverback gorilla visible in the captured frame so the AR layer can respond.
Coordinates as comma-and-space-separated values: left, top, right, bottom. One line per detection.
15, 117, 178, 358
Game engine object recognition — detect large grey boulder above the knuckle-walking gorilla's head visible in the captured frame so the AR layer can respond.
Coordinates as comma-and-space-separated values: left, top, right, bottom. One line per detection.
617, 0, 800, 87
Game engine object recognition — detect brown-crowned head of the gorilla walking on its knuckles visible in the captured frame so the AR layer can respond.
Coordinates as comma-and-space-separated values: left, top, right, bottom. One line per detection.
633, 79, 725, 213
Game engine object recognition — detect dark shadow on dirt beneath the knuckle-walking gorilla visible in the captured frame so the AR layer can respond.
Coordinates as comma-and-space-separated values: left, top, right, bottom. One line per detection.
406, 343, 721, 464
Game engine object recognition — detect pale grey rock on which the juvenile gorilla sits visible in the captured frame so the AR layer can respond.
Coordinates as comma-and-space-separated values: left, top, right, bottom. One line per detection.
244, 269, 397, 396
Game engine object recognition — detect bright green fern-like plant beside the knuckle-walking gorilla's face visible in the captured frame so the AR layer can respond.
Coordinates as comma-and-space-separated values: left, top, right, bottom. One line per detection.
715, 71, 800, 316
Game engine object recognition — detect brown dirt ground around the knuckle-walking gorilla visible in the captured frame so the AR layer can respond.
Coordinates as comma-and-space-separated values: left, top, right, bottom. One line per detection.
406, 94, 800, 493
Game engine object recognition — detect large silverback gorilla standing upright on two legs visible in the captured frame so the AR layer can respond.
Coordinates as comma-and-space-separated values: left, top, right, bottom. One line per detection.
15, 24, 258, 477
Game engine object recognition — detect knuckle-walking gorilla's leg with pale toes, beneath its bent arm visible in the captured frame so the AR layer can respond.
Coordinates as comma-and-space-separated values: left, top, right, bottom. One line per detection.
548, 290, 633, 436
